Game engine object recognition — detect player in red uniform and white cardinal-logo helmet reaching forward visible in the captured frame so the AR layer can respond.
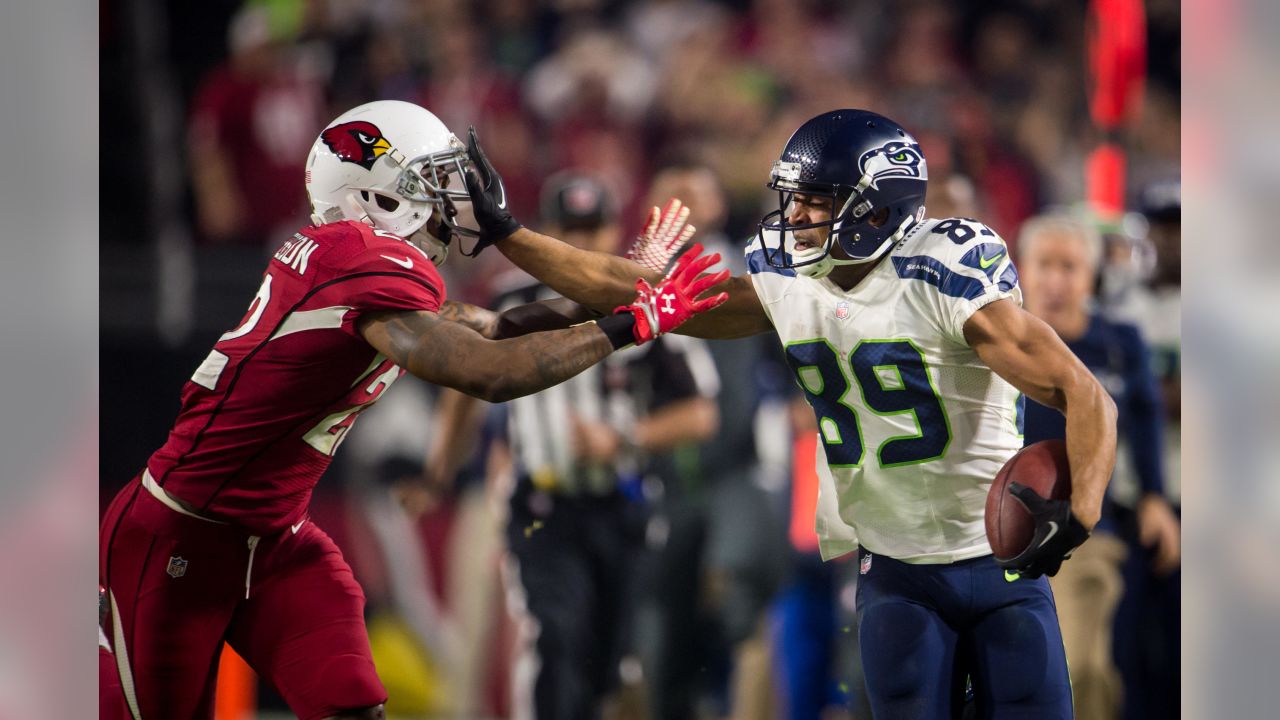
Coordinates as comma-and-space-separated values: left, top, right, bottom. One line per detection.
99, 101, 724, 720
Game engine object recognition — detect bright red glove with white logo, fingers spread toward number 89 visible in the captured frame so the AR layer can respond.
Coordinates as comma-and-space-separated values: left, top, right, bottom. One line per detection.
613, 243, 728, 345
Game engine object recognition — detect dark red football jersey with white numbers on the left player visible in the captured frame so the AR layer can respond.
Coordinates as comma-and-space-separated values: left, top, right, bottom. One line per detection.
147, 222, 444, 534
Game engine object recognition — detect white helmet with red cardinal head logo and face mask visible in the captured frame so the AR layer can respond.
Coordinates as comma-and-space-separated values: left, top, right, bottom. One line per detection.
306, 100, 470, 265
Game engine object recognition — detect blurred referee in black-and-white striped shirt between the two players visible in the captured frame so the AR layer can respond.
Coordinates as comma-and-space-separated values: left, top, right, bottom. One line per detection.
497, 174, 719, 719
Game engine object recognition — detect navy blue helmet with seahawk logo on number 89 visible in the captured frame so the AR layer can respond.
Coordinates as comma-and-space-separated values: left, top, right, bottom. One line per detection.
759, 109, 928, 277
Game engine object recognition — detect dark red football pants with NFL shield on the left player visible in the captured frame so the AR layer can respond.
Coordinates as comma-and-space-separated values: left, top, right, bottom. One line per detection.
99, 479, 387, 720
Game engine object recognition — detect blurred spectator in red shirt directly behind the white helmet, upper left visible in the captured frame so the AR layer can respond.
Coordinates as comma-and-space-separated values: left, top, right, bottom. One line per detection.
188, 5, 324, 245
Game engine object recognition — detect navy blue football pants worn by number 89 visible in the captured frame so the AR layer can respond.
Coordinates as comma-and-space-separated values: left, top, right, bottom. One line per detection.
858, 550, 1071, 720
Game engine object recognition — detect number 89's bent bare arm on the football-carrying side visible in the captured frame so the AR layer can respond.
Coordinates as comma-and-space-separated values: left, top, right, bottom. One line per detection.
964, 300, 1116, 529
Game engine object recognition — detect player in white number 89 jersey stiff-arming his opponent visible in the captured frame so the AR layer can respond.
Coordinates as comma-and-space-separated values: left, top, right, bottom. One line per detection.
467, 110, 1116, 719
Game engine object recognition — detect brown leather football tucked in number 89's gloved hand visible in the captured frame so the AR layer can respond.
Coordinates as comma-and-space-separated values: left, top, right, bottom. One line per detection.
987, 439, 1071, 560
